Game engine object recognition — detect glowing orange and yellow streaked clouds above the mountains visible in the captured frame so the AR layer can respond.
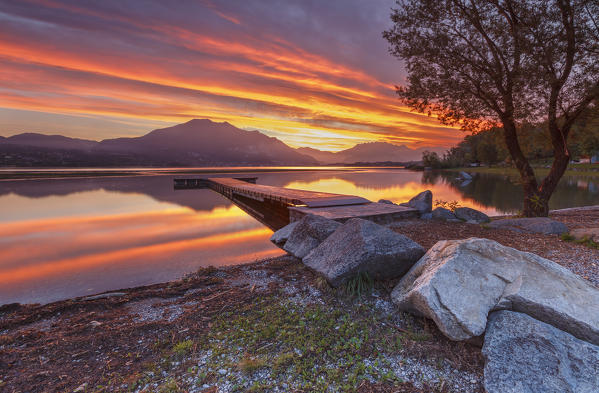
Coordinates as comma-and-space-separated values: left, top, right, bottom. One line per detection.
0, 0, 461, 150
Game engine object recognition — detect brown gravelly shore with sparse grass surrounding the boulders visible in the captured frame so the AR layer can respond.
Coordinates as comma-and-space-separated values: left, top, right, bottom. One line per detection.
0, 206, 599, 393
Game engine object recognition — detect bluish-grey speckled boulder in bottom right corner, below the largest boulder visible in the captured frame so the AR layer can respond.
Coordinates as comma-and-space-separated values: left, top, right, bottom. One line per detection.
482, 311, 599, 393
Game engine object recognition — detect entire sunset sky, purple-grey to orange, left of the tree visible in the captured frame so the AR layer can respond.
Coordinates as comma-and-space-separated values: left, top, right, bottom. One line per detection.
0, 0, 464, 151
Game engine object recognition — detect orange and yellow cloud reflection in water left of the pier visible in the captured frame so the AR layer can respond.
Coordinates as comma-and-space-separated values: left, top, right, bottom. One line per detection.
0, 201, 281, 303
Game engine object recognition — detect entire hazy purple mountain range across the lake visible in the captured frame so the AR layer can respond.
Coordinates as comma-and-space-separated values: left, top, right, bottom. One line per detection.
0, 119, 446, 167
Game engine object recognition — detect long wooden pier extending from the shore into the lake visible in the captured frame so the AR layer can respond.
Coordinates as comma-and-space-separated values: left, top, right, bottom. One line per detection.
175, 177, 418, 230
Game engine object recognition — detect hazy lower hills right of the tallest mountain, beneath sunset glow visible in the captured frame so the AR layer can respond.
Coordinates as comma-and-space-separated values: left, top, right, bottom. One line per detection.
297, 142, 444, 164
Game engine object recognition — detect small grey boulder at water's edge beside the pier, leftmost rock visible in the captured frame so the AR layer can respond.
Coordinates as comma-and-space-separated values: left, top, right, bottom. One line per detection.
283, 214, 341, 259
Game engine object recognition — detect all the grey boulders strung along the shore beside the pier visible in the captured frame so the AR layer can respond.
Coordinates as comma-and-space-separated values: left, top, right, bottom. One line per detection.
271, 199, 599, 393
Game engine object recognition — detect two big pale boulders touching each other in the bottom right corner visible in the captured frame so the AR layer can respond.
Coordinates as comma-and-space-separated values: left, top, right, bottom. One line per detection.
391, 238, 599, 393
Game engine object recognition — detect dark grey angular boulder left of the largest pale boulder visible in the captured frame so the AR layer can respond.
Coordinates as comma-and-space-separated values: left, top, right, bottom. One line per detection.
303, 218, 424, 287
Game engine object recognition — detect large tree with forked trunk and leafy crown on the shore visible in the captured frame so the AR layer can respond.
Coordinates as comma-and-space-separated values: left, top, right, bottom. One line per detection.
383, 0, 599, 216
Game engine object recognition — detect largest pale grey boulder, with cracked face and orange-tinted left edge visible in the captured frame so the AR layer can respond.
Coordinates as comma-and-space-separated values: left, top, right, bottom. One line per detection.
391, 238, 599, 344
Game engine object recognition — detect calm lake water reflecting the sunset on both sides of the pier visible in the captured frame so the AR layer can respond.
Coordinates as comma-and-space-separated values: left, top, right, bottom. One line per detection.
0, 169, 599, 304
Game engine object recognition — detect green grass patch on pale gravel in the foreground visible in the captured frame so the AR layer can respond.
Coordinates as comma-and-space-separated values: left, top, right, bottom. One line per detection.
197, 292, 418, 392
